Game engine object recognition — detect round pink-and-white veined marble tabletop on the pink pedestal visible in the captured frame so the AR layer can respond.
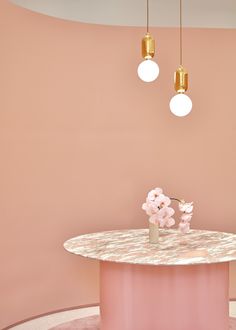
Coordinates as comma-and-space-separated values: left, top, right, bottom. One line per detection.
64, 229, 236, 265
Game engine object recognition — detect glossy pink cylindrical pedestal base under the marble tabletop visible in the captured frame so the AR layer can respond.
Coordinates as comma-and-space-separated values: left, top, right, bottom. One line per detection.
100, 261, 229, 330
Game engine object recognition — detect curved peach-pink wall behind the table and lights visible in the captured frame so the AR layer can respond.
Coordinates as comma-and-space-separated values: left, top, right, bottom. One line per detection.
0, 0, 236, 327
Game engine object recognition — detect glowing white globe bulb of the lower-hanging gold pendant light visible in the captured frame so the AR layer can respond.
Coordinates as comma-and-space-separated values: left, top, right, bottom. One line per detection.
170, 93, 193, 117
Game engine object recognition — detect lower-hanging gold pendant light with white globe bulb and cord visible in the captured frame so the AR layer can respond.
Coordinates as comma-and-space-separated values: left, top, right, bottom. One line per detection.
170, 0, 192, 117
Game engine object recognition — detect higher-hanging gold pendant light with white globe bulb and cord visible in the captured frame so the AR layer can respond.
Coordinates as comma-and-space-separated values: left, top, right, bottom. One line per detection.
137, 0, 159, 82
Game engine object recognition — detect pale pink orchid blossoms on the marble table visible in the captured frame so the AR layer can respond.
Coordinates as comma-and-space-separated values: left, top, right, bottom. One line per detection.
142, 188, 193, 233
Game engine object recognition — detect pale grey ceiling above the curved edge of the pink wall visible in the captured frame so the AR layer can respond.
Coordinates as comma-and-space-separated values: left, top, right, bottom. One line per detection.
10, 0, 236, 28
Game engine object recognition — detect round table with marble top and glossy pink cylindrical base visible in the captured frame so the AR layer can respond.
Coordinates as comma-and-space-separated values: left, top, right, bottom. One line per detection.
64, 229, 236, 330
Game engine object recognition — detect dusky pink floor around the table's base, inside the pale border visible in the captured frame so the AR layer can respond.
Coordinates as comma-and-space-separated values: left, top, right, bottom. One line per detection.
49, 315, 236, 330
